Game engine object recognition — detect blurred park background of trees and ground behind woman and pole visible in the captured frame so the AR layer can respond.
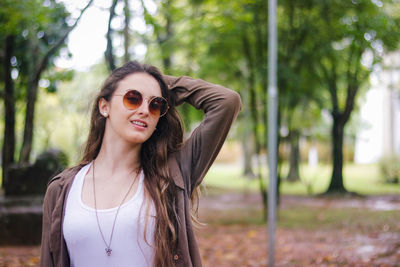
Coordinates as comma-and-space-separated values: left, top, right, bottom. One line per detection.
0, 0, 400, 266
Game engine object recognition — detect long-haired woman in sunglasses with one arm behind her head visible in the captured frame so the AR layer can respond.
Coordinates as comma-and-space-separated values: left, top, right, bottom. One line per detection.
41, 62, 241, 267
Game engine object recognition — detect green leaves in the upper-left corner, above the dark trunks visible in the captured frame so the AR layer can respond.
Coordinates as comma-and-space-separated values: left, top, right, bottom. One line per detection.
0, 0, 69, 101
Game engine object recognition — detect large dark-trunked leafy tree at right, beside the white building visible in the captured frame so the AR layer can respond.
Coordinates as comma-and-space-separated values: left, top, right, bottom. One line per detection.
314, 0, 400, 192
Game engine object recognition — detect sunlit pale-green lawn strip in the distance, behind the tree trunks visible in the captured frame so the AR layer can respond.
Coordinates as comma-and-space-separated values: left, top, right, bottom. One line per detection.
205, 164, 400, 195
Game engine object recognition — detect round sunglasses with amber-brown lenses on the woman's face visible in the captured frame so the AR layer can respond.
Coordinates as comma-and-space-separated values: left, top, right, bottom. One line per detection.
115, 89, 169, 117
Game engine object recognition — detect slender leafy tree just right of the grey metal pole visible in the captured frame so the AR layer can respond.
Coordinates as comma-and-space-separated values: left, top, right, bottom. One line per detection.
278, 0, 320, 181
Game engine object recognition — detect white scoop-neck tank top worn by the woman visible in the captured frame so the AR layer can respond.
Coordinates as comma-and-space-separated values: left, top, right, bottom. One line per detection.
63, 163, 155, 267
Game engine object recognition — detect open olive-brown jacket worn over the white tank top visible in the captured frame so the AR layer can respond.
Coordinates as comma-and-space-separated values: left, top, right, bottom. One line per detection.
40, 75, 241, 267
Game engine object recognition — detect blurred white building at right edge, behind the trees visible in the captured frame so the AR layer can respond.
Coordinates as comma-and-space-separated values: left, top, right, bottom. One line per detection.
354, 51, 400, 163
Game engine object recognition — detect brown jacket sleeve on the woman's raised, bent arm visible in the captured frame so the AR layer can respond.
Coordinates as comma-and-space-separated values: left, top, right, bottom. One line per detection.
164, 75, 241, 195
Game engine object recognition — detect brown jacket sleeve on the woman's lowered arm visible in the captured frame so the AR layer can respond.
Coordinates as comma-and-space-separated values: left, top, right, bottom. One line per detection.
40, 182, 59, 267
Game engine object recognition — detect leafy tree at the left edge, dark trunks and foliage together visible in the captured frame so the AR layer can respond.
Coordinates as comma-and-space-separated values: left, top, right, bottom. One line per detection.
0, 0, 93, 185
